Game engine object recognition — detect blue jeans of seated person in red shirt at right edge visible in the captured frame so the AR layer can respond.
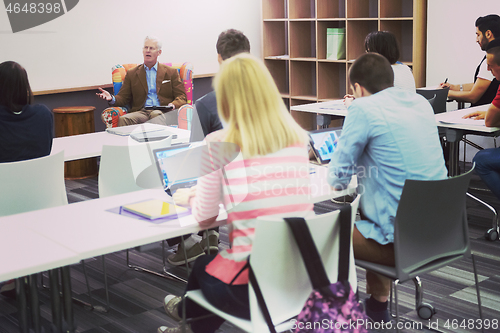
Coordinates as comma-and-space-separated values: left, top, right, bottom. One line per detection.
473, 148, 500, 199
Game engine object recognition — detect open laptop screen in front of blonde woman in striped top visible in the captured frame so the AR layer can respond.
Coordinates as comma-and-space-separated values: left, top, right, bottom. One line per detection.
153, 143, 203, 196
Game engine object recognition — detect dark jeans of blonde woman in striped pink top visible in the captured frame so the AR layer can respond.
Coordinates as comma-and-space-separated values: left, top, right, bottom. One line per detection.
178, 255, 250, 333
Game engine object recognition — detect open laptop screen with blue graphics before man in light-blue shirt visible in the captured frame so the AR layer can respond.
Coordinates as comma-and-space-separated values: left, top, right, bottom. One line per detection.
309, 127, 342, 165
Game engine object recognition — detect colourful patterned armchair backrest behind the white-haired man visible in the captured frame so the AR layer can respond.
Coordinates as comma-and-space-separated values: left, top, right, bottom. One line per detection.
111, 62, 193, 104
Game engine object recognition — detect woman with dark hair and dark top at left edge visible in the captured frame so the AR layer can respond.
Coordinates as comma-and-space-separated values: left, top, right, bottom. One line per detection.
0, 61, 54, 163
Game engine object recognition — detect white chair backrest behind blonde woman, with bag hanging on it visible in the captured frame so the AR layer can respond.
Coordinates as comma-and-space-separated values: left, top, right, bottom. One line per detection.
249, 196, 360, 332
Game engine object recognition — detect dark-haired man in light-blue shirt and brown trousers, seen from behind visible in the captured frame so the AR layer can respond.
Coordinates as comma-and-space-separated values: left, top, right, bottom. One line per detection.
328, 53, 447, 322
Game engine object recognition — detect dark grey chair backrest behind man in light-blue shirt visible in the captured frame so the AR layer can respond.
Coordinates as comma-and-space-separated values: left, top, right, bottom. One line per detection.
394, 166, 472, 280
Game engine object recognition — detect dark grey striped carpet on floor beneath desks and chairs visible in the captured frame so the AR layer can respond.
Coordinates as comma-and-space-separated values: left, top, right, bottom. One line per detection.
0, 165, 500, 333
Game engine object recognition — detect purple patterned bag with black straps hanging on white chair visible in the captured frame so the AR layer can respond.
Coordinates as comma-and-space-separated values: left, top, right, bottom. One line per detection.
285, 205, 368, 333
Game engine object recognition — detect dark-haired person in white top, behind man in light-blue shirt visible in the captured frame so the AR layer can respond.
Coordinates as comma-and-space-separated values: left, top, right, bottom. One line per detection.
365, 31, 416, 92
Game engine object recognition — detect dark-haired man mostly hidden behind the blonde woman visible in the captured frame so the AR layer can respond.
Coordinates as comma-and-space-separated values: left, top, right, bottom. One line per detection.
167, 29, 250, 265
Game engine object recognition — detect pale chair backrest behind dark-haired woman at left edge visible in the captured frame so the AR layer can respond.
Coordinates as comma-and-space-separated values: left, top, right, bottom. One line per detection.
0, 151, 68, 216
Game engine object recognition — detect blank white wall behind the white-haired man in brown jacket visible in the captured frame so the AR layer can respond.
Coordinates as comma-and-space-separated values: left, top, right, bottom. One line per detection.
0, 0, 262, 91
